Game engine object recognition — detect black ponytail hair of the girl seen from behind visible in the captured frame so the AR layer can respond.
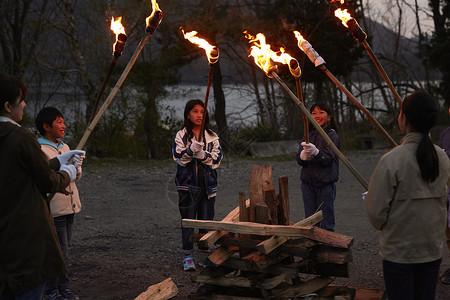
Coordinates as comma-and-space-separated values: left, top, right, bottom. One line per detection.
402, 91, 439, 182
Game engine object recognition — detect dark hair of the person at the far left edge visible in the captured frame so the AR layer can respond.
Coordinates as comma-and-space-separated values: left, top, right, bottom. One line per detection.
0, 74, 27, 114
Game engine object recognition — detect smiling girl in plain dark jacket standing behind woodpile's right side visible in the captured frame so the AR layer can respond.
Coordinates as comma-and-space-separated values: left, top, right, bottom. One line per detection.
297, 103, 341, 231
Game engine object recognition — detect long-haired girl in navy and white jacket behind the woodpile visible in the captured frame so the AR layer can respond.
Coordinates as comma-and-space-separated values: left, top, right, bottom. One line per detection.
172, 100, 222, 271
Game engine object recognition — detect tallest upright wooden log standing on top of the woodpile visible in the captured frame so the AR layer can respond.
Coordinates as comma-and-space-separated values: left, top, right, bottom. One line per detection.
249, 164, 272, 222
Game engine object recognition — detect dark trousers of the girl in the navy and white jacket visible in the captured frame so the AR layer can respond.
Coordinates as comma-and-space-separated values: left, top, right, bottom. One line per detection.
178, 188, 216, 255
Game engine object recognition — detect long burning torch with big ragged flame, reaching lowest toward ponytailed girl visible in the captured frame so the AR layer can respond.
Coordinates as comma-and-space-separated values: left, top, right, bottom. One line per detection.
246, 33, 369, 190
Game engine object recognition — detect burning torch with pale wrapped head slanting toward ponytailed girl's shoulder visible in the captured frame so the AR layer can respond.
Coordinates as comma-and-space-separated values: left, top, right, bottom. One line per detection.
294, 31, 397, 147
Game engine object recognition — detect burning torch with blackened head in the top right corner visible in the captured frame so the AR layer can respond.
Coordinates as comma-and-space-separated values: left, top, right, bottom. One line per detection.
334, 8, 402, 106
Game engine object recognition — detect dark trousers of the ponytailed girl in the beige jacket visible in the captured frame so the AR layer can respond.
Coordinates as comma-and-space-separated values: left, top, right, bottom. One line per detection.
383, 259, 442, 300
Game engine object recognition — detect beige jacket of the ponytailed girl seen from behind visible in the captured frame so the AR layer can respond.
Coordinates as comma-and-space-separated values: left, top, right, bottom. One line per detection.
365, 133, 450, 264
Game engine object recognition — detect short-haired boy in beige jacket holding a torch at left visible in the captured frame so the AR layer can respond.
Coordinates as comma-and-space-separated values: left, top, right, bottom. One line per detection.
35, 107, 84, 299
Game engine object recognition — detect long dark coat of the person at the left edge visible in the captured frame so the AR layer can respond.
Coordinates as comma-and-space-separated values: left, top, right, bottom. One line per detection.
0, 122, 70, 295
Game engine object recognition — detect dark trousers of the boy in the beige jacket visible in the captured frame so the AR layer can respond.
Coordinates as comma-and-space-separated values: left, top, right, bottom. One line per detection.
46, 214, 75, 293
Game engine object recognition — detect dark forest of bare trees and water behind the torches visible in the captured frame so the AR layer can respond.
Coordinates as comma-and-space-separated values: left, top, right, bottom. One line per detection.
0, 0, 450, 159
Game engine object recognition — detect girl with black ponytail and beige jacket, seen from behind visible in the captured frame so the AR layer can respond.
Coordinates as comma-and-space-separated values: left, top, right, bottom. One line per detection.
365, 91, 450, 300
